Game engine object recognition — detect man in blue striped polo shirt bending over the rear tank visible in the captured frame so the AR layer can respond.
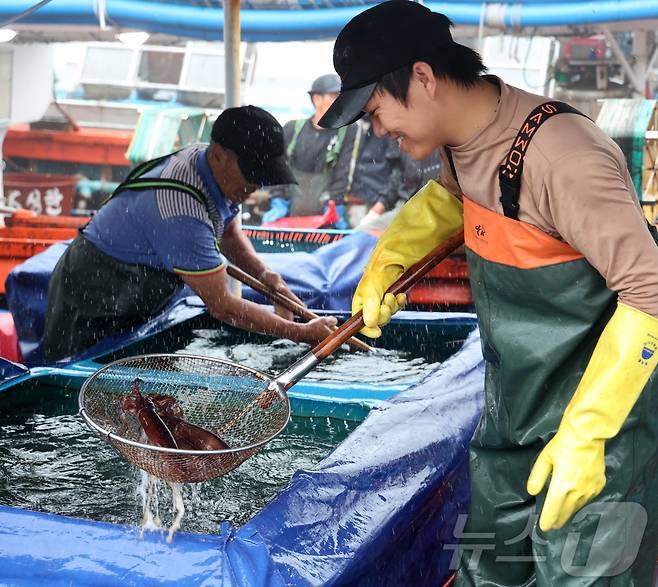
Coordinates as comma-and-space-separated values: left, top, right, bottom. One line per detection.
43, 106, 335, 361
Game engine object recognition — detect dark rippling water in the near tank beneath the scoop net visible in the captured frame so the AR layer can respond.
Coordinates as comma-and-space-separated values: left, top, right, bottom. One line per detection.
0, 388, 357, 533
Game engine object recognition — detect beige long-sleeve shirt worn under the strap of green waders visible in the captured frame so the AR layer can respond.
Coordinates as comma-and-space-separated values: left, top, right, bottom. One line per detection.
439, 78, 658, 317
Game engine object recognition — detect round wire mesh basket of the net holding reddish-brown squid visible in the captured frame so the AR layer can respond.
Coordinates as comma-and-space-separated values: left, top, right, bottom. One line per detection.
79, 354, 290, 483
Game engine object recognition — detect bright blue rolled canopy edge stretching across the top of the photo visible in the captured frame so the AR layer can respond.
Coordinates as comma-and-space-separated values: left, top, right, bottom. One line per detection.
0, 0, 658, 42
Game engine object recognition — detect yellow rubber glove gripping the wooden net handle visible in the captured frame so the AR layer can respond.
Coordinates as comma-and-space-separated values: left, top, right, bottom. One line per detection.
352, 180, 464, 338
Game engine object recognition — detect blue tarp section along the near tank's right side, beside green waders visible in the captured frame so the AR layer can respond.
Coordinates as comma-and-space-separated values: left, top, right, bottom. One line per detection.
244, 331, 484, 587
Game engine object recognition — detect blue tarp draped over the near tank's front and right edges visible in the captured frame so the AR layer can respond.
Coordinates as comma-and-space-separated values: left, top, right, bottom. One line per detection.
0, 333, 484, 587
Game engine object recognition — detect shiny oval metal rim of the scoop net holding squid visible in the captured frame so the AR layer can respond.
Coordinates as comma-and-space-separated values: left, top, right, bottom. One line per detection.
78, 353, 291, 457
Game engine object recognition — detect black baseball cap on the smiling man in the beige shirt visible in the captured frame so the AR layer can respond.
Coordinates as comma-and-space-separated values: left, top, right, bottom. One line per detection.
318, 0, 452, 128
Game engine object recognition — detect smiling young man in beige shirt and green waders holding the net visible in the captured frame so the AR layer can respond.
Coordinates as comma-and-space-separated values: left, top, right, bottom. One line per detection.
320, 0, 658, 587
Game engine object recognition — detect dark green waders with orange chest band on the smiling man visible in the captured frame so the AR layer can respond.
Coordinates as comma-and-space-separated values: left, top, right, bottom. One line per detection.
455, 105, 658, 587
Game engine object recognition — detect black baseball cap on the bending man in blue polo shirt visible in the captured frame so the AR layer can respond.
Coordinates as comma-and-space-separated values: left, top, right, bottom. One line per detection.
210, 106, 297, 185
